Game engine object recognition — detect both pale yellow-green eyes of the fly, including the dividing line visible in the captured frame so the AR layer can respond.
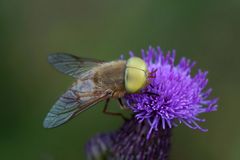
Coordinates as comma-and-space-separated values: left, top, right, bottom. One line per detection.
125, 57, 147, 93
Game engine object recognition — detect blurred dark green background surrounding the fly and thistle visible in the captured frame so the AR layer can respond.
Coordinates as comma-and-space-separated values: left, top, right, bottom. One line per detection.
0, 0, 240, 160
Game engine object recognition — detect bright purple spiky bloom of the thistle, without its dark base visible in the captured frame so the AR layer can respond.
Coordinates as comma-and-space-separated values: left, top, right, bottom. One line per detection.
124, 47, 217, 138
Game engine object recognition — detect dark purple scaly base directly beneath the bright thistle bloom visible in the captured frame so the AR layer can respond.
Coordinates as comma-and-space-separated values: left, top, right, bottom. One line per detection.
110, 118, 170, 160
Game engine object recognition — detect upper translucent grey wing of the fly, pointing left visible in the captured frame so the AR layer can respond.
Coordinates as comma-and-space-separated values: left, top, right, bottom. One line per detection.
48, 53, 104, 78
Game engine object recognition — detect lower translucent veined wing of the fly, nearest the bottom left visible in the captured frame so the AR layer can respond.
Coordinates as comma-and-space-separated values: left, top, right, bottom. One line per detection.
43, 80, 109, 128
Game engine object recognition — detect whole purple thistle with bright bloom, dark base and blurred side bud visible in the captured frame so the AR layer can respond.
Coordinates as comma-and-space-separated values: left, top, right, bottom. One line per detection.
87, 48, 217, 160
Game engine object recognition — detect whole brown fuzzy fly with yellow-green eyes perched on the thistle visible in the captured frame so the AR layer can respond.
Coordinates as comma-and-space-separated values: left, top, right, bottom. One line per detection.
43, 53, 156, 128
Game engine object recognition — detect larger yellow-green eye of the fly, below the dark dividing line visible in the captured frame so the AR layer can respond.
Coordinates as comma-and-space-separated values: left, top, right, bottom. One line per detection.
125, 68, 147, 93
